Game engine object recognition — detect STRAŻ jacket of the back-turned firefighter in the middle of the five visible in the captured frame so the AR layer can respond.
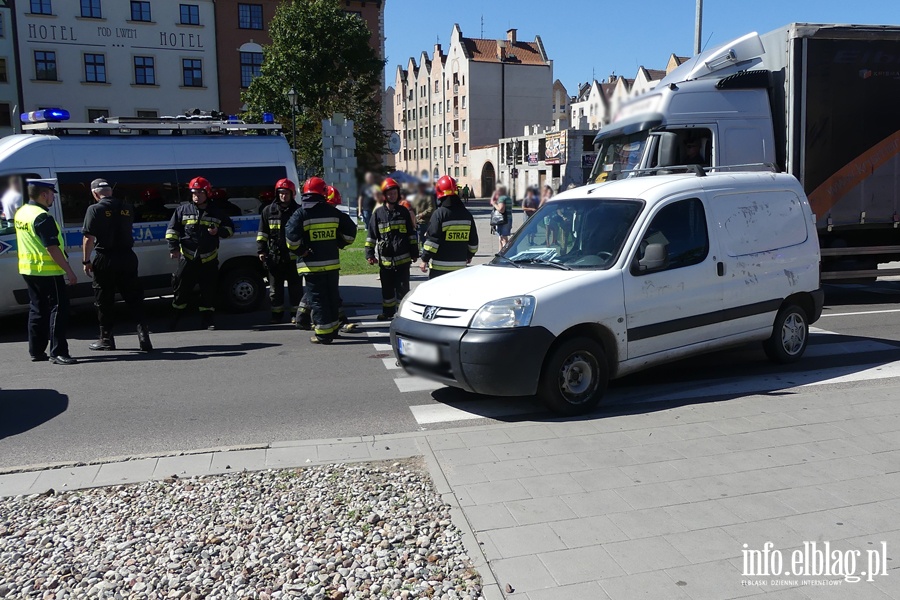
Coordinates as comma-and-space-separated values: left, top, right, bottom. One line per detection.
285, 194, 356, 273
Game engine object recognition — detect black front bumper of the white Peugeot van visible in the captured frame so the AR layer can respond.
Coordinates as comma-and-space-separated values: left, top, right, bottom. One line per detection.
391, 317, 554, 396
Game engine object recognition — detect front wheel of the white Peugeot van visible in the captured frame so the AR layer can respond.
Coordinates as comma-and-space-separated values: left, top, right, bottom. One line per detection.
539, 337, 609, 415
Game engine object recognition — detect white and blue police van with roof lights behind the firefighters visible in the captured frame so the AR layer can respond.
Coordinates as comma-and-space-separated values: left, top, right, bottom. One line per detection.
0, 109, 297, 315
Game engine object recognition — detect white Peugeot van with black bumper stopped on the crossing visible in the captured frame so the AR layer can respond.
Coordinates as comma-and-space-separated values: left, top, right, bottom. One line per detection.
391, 169, 824, 414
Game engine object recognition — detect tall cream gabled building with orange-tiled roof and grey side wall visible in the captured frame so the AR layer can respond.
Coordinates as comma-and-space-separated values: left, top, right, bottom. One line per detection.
393, 25, 554, 189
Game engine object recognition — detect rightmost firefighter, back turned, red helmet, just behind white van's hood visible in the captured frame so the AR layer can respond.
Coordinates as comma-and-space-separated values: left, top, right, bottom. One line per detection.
420, 175, 478, 279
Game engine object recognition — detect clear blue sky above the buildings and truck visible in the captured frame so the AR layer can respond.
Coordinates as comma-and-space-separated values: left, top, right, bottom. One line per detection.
384, 0, 900, 95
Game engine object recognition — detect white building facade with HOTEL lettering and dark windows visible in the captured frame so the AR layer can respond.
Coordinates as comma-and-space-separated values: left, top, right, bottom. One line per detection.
15, 0, 219, 121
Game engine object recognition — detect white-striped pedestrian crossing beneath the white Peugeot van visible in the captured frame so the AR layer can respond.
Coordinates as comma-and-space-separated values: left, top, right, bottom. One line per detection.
367, 327, 900, 425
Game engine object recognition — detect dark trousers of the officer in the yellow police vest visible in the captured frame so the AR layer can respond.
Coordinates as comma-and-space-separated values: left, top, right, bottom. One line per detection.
22, 275, 69, 358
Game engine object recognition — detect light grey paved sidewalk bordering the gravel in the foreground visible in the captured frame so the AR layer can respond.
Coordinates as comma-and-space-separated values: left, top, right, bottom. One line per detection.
0, 382, 900, 600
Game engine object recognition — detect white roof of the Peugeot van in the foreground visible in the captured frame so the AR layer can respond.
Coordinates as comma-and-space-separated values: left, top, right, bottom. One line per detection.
550, 171, 803, 203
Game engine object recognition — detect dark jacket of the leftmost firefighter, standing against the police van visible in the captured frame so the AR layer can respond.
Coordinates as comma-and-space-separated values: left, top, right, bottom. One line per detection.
166, 202, 234, 262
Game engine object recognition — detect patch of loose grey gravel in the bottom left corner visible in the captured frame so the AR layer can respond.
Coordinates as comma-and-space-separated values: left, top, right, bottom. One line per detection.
0, 459, 483, 600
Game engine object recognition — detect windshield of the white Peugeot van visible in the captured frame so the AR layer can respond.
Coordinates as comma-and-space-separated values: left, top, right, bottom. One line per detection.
491, 198, 643, 269
